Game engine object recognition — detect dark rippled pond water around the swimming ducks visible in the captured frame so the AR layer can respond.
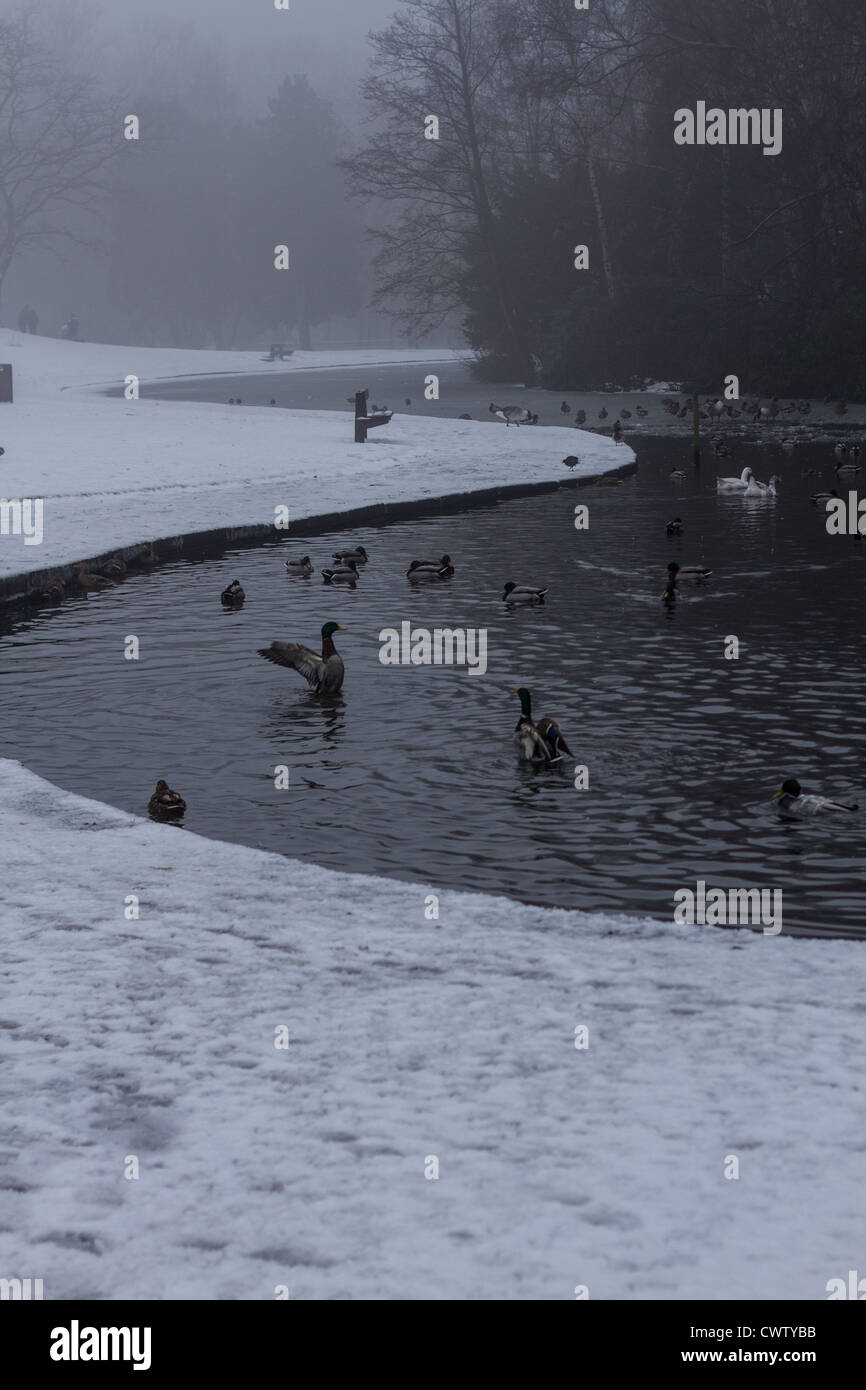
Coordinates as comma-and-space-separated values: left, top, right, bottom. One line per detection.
0, 439, 866, 937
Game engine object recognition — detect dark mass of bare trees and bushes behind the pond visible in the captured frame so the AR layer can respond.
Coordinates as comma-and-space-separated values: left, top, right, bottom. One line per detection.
348, 0, 866, 398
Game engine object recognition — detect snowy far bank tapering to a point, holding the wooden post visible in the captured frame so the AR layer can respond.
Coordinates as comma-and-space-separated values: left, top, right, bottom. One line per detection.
0, 335, 634, 586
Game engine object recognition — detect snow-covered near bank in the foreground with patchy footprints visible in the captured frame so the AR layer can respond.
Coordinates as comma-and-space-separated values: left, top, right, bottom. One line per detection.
0, 762, 866, 1300
